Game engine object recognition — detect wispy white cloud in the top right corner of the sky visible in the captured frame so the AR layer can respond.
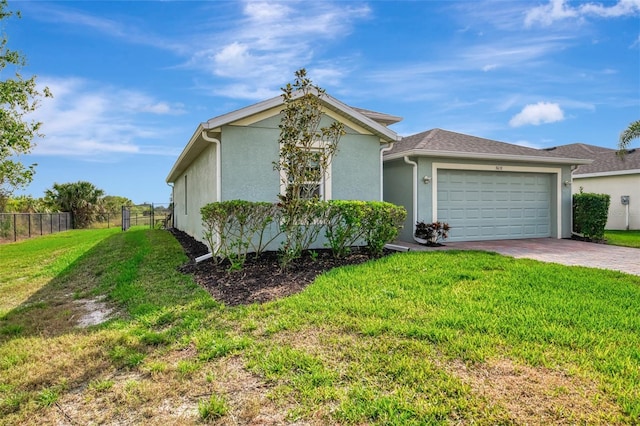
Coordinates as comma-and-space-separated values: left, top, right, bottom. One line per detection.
524, 0, 640, 27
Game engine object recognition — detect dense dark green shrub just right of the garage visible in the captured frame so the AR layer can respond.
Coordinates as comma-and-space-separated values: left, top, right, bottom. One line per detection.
573, 188, 611, 241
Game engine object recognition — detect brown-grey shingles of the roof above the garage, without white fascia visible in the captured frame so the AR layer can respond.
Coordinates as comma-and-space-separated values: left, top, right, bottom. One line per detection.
386, 129, 585, 161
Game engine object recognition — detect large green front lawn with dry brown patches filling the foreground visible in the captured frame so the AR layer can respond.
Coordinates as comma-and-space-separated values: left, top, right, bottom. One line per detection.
0, 230, 640, 424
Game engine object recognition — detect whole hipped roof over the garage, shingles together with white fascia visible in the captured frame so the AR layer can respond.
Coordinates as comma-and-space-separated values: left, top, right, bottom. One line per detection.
385, 129, 591, 164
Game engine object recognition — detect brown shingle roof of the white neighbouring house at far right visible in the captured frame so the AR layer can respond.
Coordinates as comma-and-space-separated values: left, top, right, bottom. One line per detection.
547, 143, 640, 178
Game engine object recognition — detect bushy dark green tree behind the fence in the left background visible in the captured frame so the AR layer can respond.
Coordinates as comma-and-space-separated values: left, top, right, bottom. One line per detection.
45, 181, 104, 229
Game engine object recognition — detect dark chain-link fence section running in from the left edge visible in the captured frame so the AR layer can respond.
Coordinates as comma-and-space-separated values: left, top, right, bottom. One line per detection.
0, 213, 71, 244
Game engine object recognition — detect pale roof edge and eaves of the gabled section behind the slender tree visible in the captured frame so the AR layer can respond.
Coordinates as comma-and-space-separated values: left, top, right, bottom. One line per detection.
166, 92, 401, 182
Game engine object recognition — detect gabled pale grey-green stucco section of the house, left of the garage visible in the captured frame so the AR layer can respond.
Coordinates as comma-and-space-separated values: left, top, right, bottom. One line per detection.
166, 94, 401, 245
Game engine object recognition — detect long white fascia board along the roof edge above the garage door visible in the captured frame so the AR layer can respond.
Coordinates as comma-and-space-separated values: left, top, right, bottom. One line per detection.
384, 149, 593, 165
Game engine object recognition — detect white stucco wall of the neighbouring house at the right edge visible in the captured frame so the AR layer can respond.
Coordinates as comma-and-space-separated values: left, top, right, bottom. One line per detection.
572, 174, 640, 230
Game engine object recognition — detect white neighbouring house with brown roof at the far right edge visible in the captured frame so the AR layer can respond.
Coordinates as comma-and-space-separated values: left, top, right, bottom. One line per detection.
547, 143, 640, 229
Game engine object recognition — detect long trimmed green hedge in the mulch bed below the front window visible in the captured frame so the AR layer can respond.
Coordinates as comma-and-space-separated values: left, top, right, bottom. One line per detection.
200, 200, 407, 269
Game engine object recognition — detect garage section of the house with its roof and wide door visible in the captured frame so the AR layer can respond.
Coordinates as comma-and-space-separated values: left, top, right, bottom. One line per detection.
384, 129, 591, 241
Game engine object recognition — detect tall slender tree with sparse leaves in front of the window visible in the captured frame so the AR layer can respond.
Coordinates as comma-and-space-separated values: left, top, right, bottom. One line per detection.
274, 68, 345, 266
